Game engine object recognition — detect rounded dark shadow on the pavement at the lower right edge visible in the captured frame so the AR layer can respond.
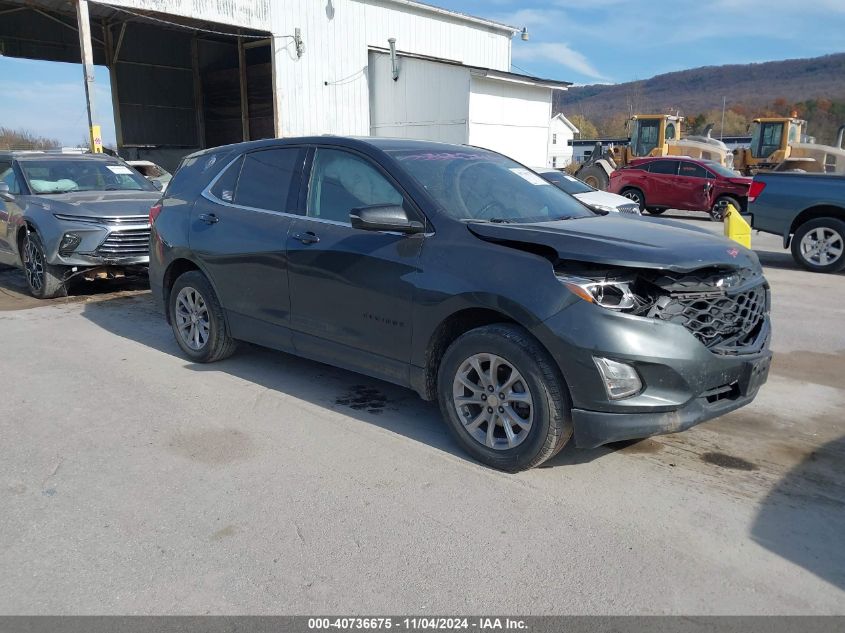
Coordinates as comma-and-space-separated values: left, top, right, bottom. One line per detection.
751, 436, 845, 589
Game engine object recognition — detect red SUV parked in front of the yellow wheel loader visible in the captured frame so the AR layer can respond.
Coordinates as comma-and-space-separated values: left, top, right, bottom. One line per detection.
607, 156, 752, 222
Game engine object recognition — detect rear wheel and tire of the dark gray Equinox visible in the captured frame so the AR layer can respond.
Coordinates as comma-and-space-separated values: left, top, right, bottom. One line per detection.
167, 270, 237, 363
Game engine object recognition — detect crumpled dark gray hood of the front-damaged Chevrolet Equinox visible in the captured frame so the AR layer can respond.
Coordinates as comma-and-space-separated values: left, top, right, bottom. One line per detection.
467, 214, 760, 272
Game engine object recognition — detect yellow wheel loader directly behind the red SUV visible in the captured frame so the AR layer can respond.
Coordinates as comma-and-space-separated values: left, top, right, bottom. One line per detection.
575, 114, 734, 189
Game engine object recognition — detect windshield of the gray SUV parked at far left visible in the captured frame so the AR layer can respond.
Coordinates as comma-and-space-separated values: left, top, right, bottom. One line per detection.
19, 158, 156, 194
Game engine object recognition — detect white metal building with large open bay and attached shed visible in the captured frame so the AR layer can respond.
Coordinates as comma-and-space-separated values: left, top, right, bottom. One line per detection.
0, 0, 568, 169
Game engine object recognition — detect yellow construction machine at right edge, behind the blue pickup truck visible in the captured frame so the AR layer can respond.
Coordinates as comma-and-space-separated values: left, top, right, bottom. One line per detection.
734, 113, 845, 176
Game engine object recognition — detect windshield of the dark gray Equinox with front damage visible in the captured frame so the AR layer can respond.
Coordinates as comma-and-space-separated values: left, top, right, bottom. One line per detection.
389, 148, 595, 222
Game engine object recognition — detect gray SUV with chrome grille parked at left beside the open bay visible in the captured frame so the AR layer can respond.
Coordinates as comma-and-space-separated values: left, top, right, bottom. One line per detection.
0, 152, 161, 299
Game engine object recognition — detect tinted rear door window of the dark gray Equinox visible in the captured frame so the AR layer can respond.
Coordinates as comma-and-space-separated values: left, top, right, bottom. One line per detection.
234, 147, 304, 212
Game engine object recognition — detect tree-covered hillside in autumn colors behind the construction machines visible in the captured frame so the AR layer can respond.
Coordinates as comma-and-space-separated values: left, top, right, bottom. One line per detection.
554, 53, 845, 143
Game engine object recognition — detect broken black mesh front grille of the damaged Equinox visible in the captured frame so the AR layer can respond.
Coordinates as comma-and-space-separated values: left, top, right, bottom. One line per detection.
648, 270, 770, 354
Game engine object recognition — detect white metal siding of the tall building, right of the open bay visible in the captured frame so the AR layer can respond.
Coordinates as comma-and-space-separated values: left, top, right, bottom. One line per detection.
272, 0, 510, 136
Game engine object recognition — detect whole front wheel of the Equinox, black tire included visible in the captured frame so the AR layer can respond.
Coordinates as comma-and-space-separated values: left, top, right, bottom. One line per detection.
437, 324, 572, 472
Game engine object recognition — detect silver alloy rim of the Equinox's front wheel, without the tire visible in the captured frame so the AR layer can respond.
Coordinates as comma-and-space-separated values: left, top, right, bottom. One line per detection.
452, 354, 534, 450
